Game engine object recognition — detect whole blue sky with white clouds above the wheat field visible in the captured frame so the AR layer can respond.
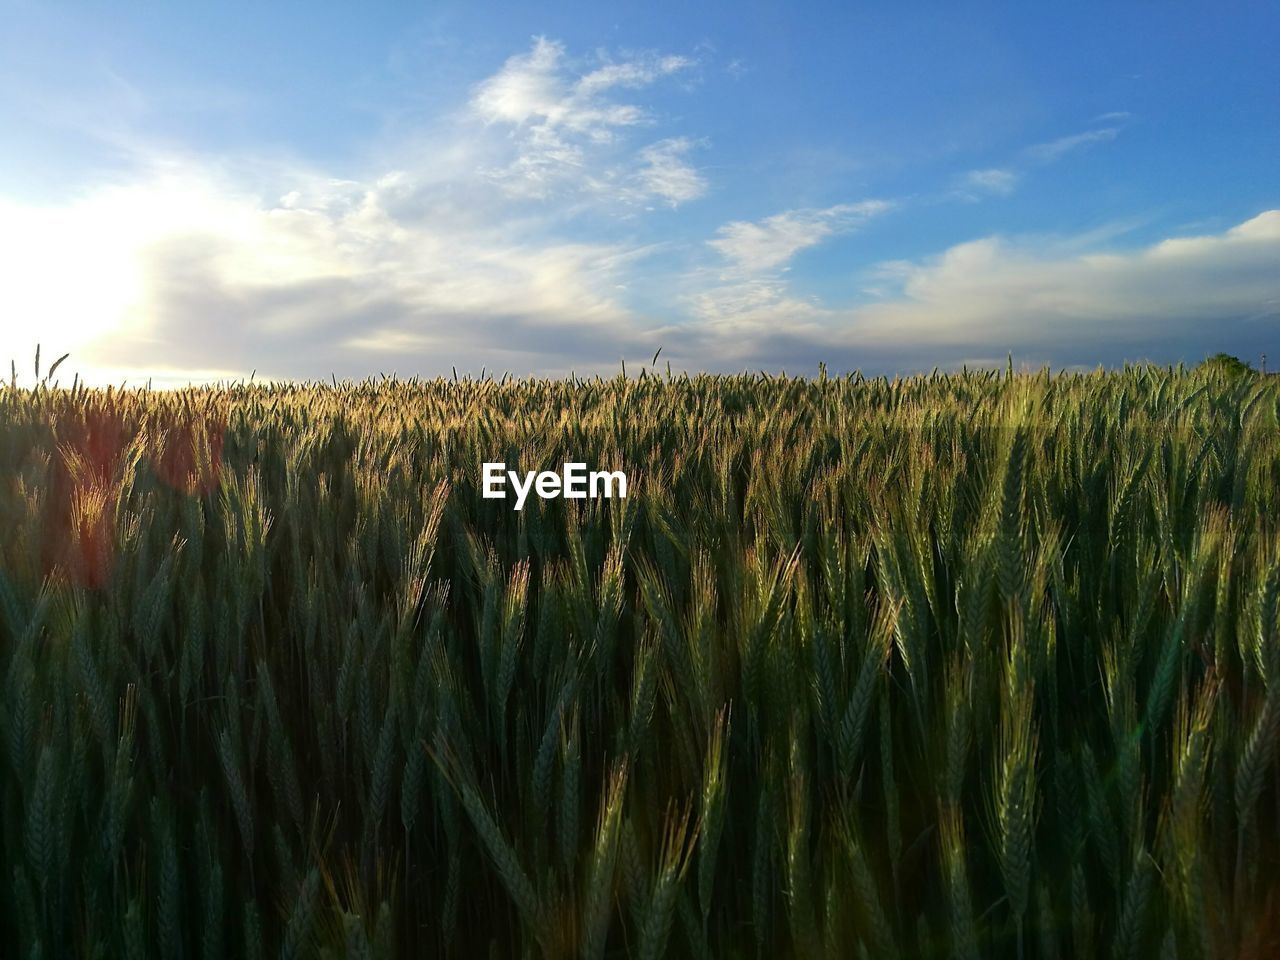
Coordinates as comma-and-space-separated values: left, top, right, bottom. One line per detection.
0, 0, 1280, 385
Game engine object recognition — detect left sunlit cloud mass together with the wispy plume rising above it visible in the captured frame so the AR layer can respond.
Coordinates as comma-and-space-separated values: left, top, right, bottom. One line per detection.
0, 40, 707, 378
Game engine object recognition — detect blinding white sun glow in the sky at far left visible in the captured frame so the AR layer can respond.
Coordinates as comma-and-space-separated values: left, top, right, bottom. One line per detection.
0, 168, 360, 383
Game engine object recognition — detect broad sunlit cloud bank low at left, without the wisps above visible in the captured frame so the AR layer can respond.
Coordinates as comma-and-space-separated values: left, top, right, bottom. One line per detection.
0, 150, 645, 381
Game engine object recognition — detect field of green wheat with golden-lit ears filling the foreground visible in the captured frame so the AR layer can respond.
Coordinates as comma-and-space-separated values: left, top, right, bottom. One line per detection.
0, 367, 1280, 960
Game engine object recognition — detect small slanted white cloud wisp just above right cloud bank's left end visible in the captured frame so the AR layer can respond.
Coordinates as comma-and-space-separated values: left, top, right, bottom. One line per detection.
708, 200, 890, 274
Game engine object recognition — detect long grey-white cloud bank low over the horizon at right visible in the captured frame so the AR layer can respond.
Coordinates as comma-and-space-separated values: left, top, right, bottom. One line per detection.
696, 210, 1280, 370
